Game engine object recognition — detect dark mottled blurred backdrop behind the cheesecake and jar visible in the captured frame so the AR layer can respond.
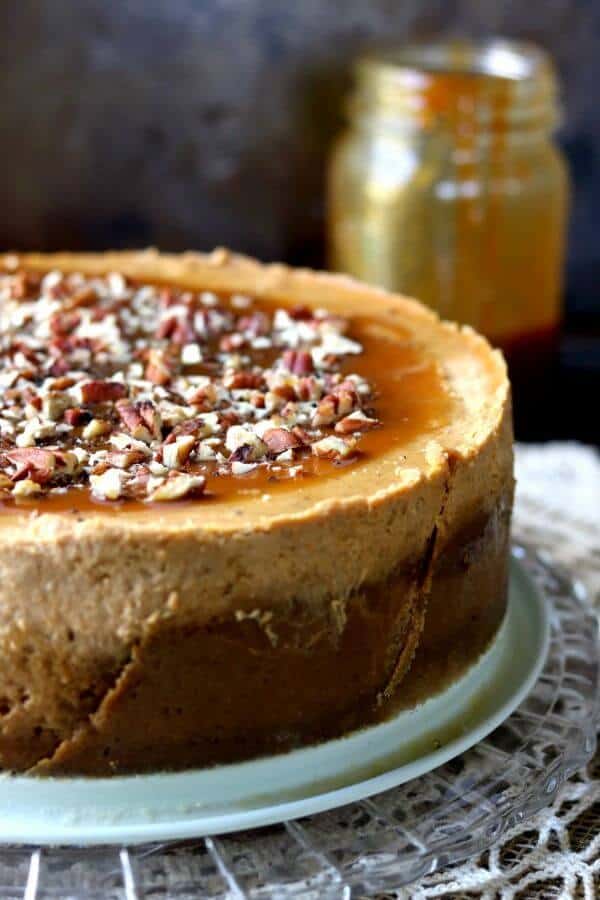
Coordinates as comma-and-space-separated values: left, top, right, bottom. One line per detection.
0, 0, 600, 443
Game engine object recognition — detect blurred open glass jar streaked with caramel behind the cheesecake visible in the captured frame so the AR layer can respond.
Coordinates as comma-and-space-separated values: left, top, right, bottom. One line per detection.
328, 40, 569, 353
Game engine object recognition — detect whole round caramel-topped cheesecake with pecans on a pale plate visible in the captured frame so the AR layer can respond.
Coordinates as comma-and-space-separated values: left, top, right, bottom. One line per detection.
0, 250, 513, 775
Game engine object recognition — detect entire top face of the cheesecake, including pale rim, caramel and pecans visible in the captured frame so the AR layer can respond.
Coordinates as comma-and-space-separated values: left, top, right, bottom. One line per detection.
0, 251, 507, 527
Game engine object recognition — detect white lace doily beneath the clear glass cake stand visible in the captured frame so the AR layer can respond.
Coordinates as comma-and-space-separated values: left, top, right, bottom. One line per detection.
392, 443, 600, 900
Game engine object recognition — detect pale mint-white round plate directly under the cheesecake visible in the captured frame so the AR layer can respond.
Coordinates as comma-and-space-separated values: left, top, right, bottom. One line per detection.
0, 560, 549, 845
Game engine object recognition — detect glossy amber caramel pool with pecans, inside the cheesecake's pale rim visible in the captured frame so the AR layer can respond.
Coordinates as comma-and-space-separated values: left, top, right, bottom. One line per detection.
0, 273, 456, 515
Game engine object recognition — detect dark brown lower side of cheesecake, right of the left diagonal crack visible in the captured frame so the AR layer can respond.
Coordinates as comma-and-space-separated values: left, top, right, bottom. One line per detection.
31, 502, 507, 775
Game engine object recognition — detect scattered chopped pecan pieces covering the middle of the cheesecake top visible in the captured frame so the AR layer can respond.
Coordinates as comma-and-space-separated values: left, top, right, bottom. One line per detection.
0, 269, 381, 502
